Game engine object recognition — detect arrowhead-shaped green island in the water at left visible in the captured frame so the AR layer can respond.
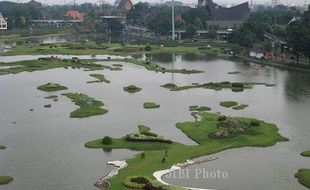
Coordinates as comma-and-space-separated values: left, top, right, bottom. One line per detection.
63, 93, 108, 118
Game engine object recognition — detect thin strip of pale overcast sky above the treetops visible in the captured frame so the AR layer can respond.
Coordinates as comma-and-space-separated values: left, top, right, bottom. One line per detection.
0, 0, 310, 4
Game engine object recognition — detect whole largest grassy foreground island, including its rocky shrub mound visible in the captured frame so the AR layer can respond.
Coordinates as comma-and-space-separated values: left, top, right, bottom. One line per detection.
85, 112, 287, 190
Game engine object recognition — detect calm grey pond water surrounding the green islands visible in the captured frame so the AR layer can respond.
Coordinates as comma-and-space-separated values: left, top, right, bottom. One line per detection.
0, 54, 310, 190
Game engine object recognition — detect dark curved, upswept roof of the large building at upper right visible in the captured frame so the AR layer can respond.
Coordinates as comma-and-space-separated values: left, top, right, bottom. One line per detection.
206, 0, 250, 20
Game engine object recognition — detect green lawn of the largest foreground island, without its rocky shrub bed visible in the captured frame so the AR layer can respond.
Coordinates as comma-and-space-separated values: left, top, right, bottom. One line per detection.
85, 112, 287, 190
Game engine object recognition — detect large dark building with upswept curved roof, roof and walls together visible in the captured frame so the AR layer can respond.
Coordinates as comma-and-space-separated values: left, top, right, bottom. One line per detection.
198, 0, 250, 29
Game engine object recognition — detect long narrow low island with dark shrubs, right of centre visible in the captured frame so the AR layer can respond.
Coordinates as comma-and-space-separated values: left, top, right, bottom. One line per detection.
161, 81, 267, 92
